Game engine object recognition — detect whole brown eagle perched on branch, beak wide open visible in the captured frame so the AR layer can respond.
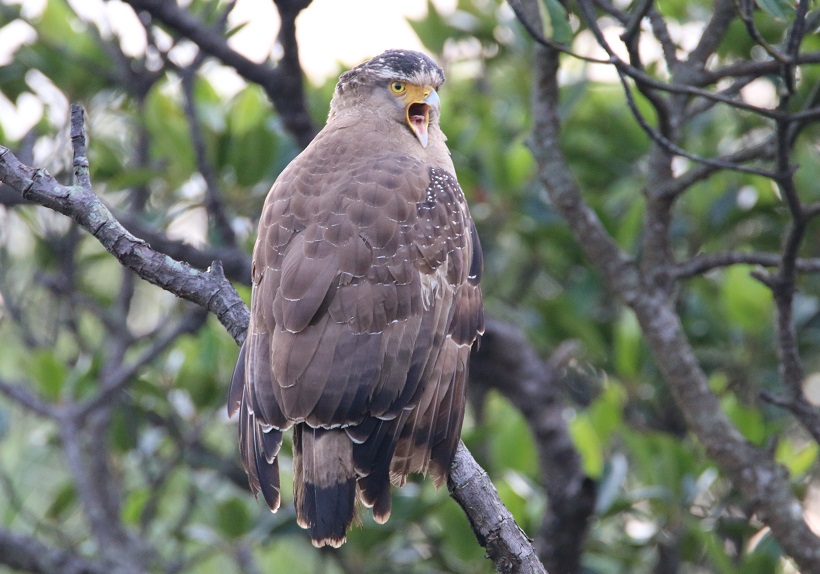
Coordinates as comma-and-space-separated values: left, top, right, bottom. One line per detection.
228, 50, 484, 547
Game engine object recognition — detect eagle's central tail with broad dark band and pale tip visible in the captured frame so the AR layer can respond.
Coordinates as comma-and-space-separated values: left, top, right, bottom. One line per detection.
293, 423, 357, 548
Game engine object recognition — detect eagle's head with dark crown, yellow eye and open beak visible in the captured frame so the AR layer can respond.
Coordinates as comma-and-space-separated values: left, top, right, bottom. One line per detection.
330, 50, 444, 147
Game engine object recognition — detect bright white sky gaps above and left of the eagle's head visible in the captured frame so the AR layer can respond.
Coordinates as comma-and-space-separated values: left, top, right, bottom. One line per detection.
0, 0, 456, 140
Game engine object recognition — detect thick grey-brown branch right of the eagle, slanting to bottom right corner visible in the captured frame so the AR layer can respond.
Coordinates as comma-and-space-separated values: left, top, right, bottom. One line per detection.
533, 39, 820, 572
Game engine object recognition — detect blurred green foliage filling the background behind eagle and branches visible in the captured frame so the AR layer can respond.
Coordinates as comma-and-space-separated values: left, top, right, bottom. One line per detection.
0, 0, 820, 574
